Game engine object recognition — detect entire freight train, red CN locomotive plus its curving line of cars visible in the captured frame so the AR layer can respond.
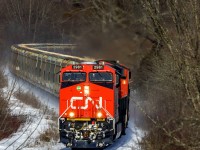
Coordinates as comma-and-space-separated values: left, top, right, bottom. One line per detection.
10, 44, 131, 149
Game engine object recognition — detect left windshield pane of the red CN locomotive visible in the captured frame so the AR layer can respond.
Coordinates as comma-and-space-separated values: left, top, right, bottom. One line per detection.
62, 72, 86, 81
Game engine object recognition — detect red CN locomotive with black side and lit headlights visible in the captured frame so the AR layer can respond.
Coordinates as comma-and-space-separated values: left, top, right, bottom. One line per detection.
59, 60, 131, 149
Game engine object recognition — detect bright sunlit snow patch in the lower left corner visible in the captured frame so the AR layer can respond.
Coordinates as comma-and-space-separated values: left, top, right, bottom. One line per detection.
0, 86, 51, 150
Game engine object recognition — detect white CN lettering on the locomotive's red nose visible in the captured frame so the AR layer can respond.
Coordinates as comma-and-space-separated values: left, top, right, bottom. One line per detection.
70, 97, 102, 109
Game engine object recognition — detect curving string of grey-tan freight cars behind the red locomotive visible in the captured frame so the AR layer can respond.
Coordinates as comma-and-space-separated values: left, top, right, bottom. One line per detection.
10, 43, 94, 96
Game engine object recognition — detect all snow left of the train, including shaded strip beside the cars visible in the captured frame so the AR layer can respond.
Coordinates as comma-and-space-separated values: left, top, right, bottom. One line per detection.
0, 69, 64, 150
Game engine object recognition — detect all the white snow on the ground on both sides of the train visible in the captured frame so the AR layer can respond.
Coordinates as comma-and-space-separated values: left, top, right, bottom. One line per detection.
0, 69, 144, 150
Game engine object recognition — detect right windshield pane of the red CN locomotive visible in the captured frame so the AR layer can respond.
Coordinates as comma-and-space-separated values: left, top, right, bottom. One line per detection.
89, 72, 112, 82
